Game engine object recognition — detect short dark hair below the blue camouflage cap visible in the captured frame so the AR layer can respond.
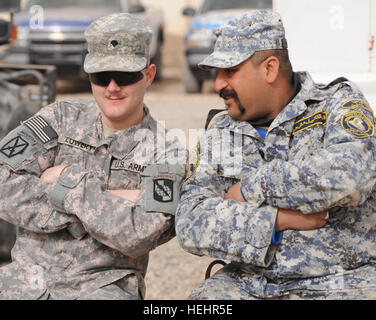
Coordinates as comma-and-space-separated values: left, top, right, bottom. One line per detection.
251, 49, 294, 81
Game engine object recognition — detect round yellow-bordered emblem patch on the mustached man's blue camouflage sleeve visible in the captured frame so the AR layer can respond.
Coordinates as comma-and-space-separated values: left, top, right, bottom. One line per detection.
341, 111, 375, 139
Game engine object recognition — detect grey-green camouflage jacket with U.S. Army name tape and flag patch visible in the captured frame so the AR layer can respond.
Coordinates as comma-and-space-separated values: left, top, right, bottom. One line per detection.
0, 101, 185, 299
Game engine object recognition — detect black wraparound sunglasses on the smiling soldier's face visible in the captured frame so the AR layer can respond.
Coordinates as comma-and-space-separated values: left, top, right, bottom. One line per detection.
89, 71, 144, 87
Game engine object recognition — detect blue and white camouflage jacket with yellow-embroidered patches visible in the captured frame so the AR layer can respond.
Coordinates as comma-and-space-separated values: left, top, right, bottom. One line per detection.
175, 73, 376, 296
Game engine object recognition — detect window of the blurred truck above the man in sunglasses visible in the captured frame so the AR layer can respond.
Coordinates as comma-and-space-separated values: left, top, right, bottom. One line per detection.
26, 0, 121, 11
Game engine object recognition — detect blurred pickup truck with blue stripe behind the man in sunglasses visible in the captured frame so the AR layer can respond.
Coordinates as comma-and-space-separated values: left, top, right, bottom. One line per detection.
4, 0, 163, 78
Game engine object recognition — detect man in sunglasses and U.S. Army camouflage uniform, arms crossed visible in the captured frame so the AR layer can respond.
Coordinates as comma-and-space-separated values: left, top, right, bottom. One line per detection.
0, 14, 185, 300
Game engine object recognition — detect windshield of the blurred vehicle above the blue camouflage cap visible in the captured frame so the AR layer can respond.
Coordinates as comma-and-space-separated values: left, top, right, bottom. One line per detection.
199, 0, 273, 13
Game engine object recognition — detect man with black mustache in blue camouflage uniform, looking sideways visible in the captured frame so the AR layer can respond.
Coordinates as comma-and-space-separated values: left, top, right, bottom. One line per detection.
175, 11, 376, 299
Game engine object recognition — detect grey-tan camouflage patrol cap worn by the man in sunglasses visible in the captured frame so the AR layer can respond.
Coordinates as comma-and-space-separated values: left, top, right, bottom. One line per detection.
84, 13, 153, 73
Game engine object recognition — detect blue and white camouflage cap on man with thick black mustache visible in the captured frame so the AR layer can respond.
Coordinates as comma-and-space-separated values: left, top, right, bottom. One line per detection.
199, 10, 287, 69
